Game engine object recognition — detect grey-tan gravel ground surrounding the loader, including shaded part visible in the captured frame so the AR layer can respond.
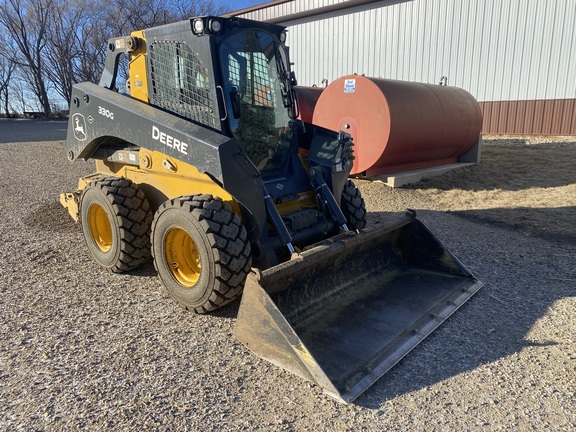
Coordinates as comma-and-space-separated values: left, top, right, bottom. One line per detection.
0, 125, 576, 431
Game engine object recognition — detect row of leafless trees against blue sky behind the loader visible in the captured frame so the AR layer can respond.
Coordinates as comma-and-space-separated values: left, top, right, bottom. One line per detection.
0, 0, 230, 116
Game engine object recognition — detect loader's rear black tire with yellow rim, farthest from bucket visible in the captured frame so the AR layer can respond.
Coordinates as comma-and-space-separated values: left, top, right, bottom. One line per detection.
80, 177, 153, 273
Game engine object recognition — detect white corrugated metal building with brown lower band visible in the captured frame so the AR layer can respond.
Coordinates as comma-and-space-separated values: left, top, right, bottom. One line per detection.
229, 0, 576, 135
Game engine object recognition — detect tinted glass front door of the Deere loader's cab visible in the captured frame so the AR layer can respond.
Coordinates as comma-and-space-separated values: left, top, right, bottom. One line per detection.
219, 29, 310, 199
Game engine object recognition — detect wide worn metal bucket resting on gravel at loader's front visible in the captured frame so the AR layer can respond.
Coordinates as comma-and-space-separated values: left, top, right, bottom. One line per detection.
235, 214, 482, 402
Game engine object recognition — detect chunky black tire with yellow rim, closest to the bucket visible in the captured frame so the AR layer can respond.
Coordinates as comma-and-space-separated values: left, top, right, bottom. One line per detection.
151, 195, 252, 313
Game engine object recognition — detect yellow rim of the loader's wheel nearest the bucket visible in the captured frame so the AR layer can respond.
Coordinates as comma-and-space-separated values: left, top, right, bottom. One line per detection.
164, 228, 202, 287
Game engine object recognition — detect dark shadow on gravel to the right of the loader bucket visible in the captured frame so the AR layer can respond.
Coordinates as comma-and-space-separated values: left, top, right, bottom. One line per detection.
355, 207, 576, 409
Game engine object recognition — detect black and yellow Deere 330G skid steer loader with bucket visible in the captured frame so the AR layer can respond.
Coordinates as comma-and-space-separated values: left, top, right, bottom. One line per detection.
60, 16, 481, 402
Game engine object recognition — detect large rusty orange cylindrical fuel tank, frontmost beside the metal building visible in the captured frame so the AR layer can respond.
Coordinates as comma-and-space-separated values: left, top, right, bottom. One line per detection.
310, 75, 482, 176
